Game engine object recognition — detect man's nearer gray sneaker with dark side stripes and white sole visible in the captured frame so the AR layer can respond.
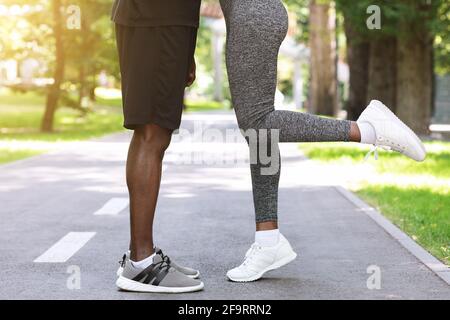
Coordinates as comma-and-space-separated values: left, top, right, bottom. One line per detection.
116, 250, 203, 293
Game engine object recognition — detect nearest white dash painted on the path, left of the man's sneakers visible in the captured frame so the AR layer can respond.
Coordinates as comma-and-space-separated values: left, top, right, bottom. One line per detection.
34, 232, 96, 263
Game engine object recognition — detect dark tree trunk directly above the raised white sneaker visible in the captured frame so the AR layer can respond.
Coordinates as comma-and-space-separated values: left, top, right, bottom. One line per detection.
367, 36, 397, 112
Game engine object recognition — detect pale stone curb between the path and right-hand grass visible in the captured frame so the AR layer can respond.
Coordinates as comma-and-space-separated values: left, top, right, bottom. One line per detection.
335, 186, 450, 285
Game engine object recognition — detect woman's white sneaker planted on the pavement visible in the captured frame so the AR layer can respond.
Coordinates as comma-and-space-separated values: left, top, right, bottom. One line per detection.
227, 234, 297, 282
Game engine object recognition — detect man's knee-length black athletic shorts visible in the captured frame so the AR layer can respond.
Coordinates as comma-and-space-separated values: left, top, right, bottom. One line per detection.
116, 24, 197, 130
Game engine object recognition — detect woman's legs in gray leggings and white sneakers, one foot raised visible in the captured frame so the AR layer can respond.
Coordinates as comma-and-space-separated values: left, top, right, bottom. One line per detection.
221, 0, 425, 282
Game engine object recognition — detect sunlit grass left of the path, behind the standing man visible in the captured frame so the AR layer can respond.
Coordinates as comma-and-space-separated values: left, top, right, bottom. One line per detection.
0, 90, 123, 163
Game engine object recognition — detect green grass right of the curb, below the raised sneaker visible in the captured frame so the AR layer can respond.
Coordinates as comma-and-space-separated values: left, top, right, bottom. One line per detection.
301, 141, 450, 264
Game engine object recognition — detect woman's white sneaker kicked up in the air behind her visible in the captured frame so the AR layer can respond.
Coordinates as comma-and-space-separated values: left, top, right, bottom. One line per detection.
356, 100, 426, 161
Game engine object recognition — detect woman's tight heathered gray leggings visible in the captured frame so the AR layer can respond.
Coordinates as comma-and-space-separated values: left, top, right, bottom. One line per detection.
220, 0, 350, 222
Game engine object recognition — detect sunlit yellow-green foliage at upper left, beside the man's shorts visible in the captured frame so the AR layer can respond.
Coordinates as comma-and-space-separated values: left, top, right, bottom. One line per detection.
0, 0, 119, 104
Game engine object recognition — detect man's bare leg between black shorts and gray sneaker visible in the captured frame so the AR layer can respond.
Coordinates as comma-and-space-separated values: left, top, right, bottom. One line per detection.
126, 124, 172, 261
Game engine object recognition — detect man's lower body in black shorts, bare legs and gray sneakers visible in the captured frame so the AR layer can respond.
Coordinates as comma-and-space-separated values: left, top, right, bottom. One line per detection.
116, 21, 203, 293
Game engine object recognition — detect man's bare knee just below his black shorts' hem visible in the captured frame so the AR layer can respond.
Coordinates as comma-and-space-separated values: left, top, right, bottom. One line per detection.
134, 124, 172, 157
